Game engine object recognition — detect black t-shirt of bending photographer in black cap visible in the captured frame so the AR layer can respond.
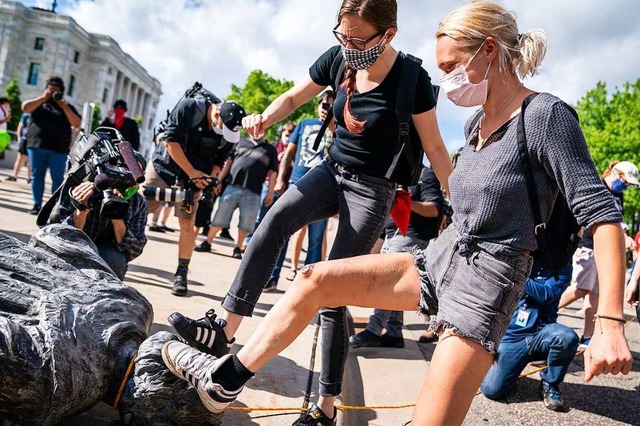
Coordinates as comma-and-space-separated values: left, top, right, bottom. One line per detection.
164, 99, 234, 184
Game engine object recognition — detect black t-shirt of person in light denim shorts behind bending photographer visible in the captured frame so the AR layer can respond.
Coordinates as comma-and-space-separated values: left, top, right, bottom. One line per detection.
229, 138, 278, 195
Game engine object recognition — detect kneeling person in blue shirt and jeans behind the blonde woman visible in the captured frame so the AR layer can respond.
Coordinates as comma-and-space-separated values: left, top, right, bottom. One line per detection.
480, 265, 579, 411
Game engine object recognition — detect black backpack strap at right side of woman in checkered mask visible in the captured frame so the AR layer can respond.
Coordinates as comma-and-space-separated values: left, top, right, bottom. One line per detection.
385, 53, 422, 180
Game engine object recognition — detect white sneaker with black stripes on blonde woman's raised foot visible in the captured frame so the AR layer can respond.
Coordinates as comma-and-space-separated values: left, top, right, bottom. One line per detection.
162, 340, 244, 413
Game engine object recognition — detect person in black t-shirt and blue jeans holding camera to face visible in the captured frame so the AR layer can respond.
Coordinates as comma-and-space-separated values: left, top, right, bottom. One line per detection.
22, 77, 80, 215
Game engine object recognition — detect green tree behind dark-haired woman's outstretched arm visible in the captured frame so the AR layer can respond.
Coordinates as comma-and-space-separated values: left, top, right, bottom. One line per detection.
228, 70, 318, 141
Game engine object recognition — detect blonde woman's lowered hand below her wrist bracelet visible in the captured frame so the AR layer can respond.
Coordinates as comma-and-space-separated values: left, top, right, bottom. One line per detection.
584, 318, 633, 382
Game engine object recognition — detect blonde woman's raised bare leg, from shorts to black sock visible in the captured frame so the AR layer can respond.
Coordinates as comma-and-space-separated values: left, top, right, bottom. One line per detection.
235, 253, 420, 372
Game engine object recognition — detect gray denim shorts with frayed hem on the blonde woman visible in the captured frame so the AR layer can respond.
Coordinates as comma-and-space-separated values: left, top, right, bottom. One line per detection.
412, 225, 533, 354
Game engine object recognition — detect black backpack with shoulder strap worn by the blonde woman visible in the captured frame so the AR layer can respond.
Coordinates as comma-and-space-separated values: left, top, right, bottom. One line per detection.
517, 93, 582, 275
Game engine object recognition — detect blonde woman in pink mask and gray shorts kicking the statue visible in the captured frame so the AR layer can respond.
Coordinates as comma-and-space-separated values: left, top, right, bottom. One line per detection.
163, 2, 632, 425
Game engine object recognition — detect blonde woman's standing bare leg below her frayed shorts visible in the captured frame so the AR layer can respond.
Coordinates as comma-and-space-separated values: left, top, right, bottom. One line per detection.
411, 336, 493, 425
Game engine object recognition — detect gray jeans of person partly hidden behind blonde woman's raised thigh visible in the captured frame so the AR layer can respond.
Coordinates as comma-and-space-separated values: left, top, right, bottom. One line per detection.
366, 235, 429, 337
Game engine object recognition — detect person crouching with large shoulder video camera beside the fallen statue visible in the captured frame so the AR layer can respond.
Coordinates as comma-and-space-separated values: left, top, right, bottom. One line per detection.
60, 182, 149, 280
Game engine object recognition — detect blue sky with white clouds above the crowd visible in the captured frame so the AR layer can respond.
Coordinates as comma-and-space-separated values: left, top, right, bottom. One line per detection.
17, 0, 640, 150
